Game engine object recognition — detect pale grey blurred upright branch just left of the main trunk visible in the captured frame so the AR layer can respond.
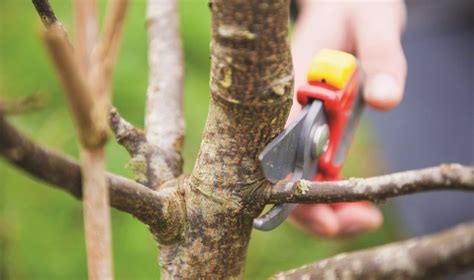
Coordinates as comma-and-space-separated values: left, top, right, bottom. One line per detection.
145, 0, 184, 176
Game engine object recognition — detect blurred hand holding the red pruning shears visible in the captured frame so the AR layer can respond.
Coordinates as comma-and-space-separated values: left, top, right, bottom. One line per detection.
289, 0, 406, 236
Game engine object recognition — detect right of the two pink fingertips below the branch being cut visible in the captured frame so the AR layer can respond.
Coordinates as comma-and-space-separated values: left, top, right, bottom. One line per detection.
333, 202, 383, 236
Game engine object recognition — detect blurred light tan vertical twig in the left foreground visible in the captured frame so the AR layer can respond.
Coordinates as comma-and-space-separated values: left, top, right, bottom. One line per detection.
75, 0, 113, 280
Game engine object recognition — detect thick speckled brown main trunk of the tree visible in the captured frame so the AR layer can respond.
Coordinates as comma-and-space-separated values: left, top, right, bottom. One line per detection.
155, 0, 292, 279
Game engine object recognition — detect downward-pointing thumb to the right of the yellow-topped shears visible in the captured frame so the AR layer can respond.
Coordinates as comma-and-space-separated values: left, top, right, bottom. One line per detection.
351, 1, 407, 110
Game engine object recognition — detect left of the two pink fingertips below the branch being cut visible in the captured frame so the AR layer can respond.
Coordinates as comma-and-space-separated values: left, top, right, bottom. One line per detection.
292, 204, 339, 237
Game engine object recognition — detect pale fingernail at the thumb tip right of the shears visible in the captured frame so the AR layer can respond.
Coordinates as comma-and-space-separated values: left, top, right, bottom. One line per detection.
366, 73, 400, 102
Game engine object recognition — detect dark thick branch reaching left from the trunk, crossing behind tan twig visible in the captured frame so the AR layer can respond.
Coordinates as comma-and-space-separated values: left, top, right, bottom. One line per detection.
0, 115, 181, 228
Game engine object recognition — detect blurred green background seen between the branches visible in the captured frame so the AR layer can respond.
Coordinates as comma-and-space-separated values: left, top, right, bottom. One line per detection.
0, 0, 398, 279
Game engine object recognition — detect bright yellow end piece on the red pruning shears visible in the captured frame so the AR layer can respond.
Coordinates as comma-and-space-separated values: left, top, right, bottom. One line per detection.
307, 49, 357, 89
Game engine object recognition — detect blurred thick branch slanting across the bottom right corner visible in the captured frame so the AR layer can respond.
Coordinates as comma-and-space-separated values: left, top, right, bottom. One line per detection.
273, 222, 474, 280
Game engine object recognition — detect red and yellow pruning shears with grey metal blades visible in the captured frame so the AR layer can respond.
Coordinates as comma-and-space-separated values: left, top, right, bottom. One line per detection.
253, 49, 364, 231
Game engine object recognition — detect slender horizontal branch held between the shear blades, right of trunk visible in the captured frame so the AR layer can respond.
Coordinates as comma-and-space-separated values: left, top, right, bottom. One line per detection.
264, 164, 474, 203
